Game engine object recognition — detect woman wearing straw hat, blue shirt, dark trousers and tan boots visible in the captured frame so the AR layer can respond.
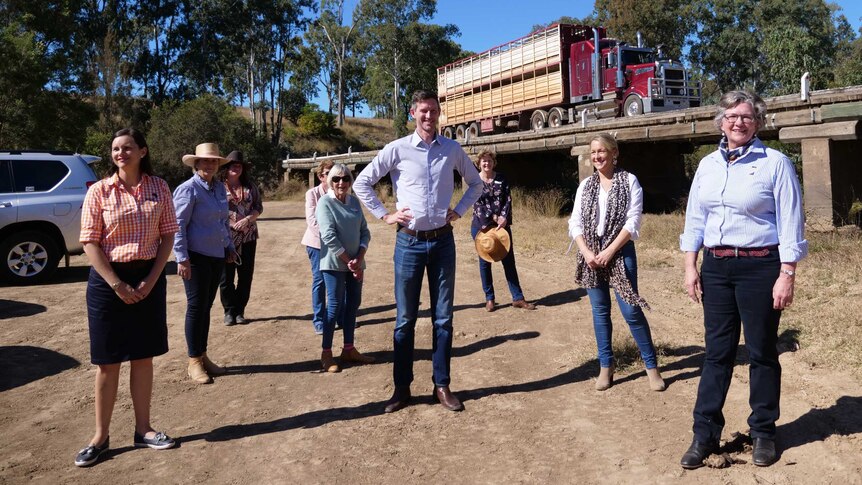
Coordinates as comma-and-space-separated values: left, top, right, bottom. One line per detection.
174, 143, 236, 384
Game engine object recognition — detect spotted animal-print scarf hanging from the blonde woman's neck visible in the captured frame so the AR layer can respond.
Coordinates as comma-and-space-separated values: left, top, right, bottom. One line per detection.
575, 168, 650, 310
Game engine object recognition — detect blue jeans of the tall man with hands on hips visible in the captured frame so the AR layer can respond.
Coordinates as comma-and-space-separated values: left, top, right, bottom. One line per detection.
392, 232, 455, 386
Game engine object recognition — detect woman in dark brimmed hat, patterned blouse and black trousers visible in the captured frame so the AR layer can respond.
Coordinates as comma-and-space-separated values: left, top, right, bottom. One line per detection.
219, 150, 263, 325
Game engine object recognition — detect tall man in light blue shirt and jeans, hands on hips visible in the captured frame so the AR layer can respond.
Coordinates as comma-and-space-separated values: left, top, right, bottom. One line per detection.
353, 90, 482, 413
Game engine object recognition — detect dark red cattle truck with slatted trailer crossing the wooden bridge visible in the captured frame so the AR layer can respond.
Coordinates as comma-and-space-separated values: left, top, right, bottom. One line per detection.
437, 24, 700, 140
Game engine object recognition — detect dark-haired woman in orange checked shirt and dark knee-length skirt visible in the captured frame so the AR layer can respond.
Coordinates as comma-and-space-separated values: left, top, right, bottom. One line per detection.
75, 128, 177, 466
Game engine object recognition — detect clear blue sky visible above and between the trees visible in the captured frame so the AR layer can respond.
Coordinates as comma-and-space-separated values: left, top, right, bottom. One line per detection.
322, 0, 862, 116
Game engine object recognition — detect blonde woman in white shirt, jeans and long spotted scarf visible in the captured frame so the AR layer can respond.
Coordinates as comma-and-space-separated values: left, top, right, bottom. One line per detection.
569, 133, 665, 391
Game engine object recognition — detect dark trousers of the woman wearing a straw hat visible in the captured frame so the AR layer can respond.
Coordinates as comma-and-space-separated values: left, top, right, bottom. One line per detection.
183, 251, 224, 357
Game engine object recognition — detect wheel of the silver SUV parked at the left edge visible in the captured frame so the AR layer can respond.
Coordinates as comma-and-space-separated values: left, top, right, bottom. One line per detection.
0, 231, 60, 285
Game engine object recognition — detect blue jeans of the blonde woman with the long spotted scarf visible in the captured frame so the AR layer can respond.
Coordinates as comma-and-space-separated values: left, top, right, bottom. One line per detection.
587, 241, 657, 369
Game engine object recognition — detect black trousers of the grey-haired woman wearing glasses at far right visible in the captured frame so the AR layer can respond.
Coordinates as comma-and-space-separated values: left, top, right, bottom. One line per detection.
693, 250, 781, 443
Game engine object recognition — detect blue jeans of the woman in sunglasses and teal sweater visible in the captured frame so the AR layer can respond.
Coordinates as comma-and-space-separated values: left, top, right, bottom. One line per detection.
321, 271, 362, 350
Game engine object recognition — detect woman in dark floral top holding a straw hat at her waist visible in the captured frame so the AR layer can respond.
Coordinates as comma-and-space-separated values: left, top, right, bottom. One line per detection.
470, 150, 536, 312
